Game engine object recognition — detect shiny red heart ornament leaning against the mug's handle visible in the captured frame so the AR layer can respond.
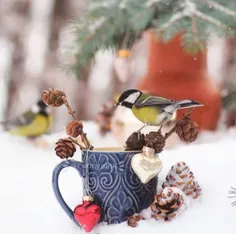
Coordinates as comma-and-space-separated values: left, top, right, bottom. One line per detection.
74, 201, 102, 232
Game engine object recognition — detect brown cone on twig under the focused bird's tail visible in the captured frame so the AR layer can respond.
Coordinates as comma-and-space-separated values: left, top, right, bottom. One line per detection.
176, 117, 199, 142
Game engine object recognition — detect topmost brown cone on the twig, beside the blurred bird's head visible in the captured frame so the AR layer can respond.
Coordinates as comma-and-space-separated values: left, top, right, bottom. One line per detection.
41, 88, 66, 107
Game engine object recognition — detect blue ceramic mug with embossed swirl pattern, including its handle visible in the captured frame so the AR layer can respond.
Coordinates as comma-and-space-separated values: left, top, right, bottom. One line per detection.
52, 149, 157, 225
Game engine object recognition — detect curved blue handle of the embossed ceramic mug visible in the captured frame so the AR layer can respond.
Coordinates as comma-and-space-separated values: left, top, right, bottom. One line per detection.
52, 160, 85, 226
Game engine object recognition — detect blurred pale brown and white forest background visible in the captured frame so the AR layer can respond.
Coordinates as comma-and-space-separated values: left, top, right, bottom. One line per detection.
0, 0, 236, 131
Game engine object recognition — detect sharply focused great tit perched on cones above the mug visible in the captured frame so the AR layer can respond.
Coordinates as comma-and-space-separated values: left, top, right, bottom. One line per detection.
116, 89, 203, 131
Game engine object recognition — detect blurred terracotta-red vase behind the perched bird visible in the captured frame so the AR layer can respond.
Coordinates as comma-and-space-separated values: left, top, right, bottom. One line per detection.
137, 33, 221, 130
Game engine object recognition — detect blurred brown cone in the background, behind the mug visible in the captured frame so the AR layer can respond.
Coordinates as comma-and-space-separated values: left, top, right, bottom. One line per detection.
96, 100, 115, 135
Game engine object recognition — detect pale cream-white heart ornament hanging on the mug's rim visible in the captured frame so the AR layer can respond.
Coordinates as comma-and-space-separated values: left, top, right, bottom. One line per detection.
131, 150, 162, 184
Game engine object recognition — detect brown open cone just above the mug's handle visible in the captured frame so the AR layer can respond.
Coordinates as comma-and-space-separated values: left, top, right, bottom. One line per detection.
55, 138, 76, 159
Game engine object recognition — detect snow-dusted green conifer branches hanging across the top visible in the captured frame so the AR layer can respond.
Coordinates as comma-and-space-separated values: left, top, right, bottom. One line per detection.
69, 0, 236, 77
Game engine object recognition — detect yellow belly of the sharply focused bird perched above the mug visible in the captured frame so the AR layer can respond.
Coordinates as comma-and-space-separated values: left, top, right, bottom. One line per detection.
132, 106, 158, 126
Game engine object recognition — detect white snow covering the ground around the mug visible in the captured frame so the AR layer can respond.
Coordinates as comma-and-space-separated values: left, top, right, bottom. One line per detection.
0, 123, 236, 234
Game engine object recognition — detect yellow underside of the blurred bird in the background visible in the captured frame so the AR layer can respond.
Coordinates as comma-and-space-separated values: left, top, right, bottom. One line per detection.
10, 115, 52, 137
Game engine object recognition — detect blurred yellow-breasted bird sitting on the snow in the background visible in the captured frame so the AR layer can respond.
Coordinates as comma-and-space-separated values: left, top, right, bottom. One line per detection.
1, 100, 52, 138
